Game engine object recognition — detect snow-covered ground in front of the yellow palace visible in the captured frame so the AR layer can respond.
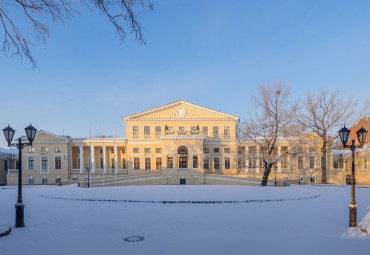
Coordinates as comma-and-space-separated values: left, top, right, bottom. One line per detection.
0, 185, 370, 255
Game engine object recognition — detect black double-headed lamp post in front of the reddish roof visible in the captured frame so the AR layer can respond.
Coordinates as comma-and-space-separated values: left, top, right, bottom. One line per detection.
339, 126, 367, 227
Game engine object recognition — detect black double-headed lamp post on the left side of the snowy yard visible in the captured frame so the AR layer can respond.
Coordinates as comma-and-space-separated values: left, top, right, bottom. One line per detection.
3, 124, 37, 228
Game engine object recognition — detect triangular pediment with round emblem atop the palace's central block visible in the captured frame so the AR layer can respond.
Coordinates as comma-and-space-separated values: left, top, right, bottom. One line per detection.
122, 100, 239, 121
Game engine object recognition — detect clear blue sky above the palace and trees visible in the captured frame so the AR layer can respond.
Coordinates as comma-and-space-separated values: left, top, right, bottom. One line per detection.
0, 0, 370, 147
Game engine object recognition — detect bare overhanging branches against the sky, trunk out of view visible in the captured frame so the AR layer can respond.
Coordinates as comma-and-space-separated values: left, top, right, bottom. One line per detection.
0, 0, 153, 67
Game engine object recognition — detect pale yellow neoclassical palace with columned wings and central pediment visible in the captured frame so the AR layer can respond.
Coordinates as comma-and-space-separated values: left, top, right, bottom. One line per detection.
7, 100, 370, 185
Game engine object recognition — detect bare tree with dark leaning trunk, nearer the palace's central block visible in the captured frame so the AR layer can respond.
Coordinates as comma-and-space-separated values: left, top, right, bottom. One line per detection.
239, 80, 301, 186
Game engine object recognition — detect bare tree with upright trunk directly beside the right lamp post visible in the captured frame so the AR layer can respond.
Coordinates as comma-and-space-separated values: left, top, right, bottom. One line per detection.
296, 88, 365, 183
